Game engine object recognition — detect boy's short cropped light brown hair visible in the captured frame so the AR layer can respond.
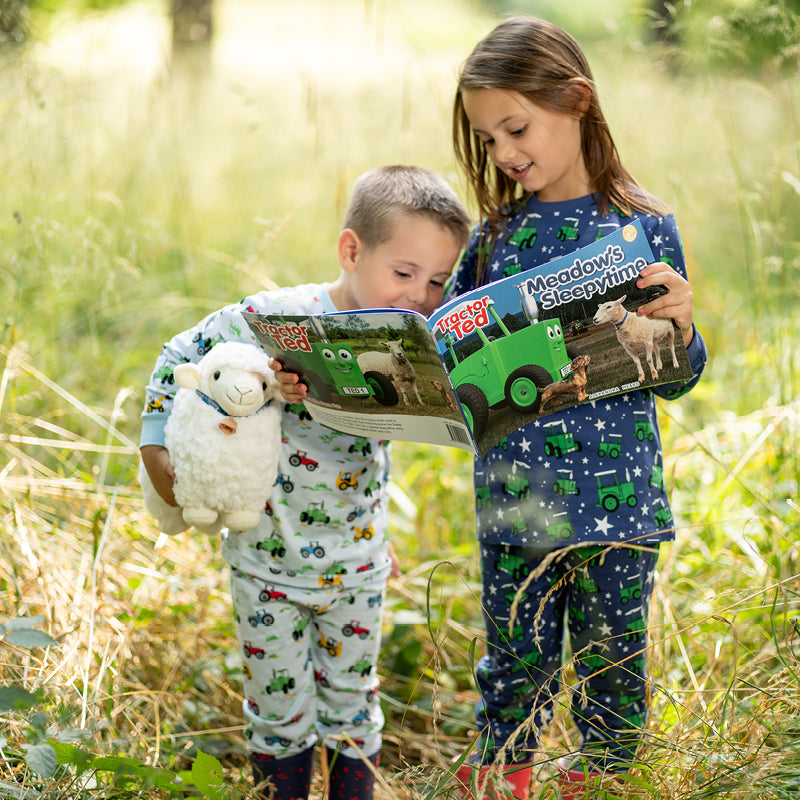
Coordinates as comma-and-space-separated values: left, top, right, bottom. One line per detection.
342, 165, 471, 248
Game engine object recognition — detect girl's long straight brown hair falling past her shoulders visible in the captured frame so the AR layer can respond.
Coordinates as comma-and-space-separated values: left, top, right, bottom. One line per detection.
453, 17, 668, 283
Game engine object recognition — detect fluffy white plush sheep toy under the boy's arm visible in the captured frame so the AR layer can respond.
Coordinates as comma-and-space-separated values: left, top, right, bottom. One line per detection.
139, 342, 281, 534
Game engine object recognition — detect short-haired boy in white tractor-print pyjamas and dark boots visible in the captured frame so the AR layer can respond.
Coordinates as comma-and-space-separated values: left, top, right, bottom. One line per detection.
141, 166, 470, 800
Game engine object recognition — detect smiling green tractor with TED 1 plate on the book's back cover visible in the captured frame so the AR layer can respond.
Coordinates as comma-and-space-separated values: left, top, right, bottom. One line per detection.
277, 317, 398, 406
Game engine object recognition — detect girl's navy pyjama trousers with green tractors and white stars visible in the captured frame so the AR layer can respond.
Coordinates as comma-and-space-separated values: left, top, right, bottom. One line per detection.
476, 543, 658, 765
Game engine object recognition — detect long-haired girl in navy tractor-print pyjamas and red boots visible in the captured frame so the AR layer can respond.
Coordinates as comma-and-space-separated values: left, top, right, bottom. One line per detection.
449, 18, 706, 798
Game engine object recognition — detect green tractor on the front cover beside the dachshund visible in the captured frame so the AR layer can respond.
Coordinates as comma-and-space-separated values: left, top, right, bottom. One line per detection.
445, 296, 572, 439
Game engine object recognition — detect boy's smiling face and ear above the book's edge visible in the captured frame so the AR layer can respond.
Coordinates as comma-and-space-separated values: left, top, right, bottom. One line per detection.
337, 215, 461, 316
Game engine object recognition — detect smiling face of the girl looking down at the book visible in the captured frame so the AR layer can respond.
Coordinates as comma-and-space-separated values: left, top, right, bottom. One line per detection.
462, 89, 593, 203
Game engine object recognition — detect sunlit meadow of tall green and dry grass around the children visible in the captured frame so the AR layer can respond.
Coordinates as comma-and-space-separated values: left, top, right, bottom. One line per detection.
0, 0, 800, 800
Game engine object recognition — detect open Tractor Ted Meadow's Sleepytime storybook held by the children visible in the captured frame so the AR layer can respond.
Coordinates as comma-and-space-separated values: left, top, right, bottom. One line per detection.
244, 220, 692, 456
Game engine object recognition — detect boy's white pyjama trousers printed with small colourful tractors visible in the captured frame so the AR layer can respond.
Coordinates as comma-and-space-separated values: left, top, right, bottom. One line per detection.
231, 568, 386, 758
